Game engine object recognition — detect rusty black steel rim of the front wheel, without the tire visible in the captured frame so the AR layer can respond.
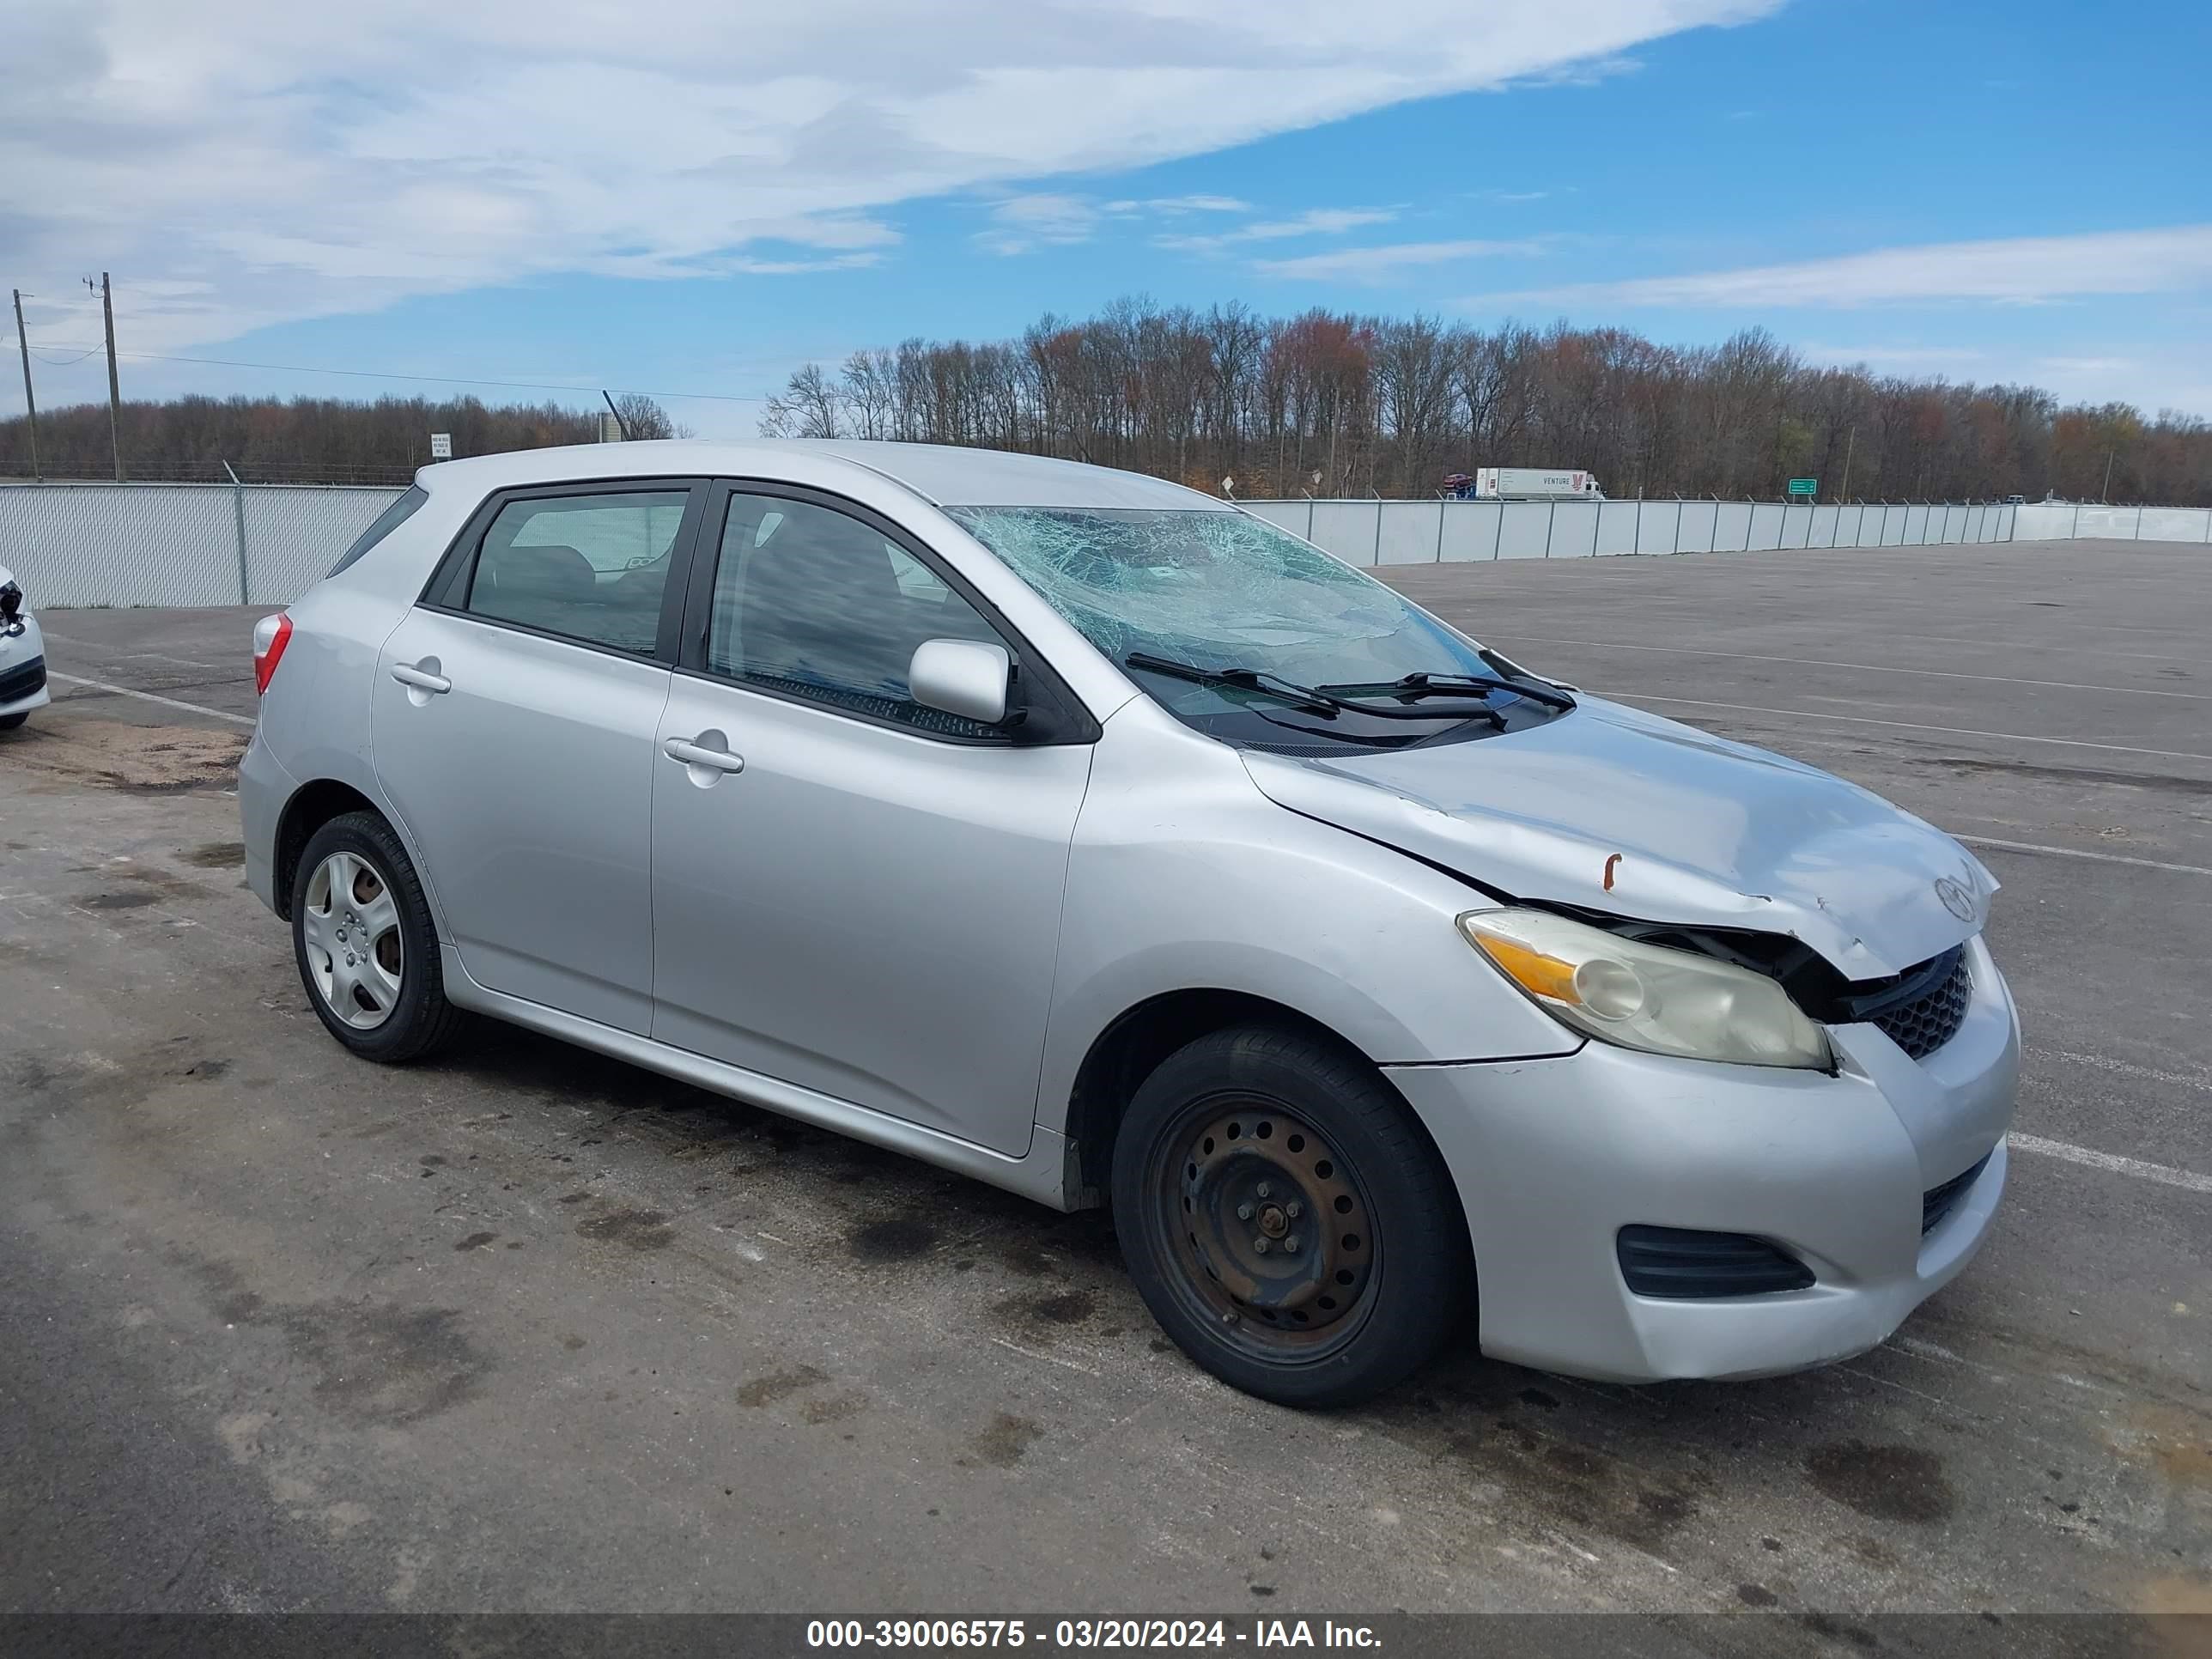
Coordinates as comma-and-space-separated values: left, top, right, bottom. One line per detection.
1155, 1097, 1382, 1363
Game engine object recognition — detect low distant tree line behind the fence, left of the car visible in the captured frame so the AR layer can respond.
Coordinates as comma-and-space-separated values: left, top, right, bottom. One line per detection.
0, 394, 688, 484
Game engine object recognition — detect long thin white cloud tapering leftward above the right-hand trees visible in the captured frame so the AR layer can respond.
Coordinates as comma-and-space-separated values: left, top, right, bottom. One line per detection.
1467, 226, 2212, 310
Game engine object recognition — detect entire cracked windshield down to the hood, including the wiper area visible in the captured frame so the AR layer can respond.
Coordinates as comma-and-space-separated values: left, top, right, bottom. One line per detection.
947, 507, 1558, 748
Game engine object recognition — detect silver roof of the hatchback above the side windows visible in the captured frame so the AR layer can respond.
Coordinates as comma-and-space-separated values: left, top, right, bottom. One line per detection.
416, 438, 1234, 511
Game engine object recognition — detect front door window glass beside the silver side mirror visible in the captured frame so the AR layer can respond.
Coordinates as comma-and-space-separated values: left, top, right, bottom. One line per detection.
708, 495, 1002, 737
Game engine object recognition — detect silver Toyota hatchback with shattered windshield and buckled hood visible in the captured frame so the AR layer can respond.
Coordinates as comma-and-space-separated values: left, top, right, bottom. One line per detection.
239, 442, 2020, 1405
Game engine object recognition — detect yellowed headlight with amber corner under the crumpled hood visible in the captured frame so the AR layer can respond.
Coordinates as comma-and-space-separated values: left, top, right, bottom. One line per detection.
1460, 909, 1836, 1071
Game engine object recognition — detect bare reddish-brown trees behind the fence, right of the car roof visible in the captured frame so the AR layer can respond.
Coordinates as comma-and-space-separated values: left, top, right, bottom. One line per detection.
761, 299, 2212, 504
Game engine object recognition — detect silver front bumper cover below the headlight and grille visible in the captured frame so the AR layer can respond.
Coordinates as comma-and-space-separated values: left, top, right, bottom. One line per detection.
1385, 940, 2020, 1382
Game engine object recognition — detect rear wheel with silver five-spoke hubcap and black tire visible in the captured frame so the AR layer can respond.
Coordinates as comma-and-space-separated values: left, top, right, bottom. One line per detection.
292, 811, 460, 1064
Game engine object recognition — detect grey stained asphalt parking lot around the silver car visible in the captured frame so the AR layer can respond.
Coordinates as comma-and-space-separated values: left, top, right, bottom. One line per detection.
0, 542, 2212, 1652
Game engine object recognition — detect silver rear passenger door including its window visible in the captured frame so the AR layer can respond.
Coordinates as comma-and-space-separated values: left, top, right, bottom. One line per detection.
369, 480, 706, 1033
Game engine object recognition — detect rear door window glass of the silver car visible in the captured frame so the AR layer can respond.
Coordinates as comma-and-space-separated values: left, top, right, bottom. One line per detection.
462, 489, 690, 657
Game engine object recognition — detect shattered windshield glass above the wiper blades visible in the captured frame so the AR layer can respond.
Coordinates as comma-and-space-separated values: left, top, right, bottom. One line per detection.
949, 507, 1498, 686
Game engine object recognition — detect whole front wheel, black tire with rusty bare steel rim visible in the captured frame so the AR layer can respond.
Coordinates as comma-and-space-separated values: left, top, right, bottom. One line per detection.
1113, 1026, 1474, 1407
